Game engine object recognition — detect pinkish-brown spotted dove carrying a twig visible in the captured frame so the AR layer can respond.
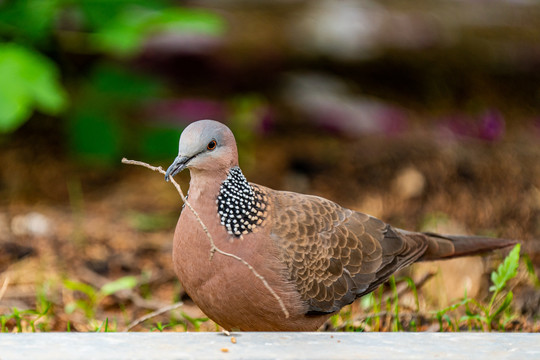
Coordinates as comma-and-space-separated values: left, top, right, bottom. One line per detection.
165, 120, 515, 331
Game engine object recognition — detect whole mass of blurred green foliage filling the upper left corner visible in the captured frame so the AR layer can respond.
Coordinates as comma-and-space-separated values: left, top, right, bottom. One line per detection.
0, 0, 225, 162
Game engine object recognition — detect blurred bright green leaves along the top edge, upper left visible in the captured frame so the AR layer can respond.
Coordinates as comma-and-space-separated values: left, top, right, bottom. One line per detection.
0, 0, 225, 54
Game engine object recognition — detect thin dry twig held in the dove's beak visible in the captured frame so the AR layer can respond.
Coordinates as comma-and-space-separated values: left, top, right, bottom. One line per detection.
122, 158, 289, 318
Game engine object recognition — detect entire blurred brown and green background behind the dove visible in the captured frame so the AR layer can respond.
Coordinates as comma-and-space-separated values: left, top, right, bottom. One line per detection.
0, 0, 540, 331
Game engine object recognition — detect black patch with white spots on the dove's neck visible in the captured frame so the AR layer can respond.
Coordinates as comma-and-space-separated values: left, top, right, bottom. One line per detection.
216, 167, 268, 237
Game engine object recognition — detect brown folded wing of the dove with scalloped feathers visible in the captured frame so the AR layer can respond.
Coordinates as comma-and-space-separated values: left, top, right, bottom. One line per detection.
270, 190, 426, 314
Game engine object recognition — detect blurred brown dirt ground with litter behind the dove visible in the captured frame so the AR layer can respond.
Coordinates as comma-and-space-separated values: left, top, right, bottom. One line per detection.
0, 119, 540, 331
